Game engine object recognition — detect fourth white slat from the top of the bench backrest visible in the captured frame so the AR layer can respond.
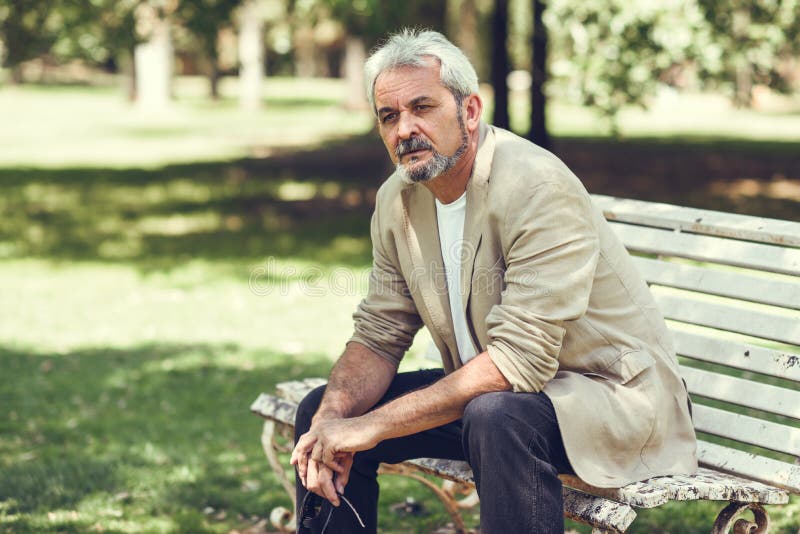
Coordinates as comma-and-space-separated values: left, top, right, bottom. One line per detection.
653, 291, 800, 345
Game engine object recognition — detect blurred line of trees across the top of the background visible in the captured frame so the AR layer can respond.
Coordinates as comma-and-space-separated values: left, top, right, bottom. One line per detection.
0, 0, 800, 136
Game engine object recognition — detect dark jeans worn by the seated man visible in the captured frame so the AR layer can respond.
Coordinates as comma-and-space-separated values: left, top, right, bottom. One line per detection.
295, 369, 572, 534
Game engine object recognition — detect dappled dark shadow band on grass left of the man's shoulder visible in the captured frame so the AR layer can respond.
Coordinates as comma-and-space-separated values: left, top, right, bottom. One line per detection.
0, 139, 385, 269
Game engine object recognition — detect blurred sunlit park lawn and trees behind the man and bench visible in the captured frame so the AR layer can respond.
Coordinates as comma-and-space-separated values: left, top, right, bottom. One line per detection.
0, 0, 800, 534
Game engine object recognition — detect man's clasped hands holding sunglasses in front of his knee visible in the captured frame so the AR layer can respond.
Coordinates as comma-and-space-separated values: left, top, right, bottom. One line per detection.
291, 417, 379, 506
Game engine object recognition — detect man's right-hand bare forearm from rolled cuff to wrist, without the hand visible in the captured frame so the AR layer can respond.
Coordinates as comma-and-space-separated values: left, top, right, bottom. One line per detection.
361, 352, 511, 441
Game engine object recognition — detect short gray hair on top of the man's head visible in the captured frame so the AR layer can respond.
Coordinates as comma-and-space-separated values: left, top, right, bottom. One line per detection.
364, 28, 478, 115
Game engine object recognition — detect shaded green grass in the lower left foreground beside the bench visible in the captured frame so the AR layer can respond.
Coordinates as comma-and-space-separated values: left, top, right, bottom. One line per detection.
0, 344, 330, 532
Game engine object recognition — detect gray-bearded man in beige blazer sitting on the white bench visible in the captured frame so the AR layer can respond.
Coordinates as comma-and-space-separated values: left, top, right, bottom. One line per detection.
291, 30, 697, 534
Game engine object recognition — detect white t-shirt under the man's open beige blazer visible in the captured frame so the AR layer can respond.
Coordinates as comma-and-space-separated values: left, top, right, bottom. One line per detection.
436, 191, 478, 363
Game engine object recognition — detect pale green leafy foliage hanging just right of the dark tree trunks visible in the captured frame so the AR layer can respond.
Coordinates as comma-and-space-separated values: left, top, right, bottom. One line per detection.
545, 0, 704, 131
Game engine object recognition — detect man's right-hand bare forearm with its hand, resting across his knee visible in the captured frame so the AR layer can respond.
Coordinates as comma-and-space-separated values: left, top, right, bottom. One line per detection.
295, 352, 511, 472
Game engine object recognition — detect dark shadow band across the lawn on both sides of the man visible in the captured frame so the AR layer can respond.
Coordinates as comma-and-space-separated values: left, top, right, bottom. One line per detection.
0, 132, 800, 276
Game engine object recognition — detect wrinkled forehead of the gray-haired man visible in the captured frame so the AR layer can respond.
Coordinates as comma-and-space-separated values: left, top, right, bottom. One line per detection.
375, 60, 449, 109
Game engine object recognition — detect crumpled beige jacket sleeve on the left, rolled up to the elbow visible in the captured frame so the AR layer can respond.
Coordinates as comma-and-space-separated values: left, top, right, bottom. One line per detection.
348, 201, 422, 366
